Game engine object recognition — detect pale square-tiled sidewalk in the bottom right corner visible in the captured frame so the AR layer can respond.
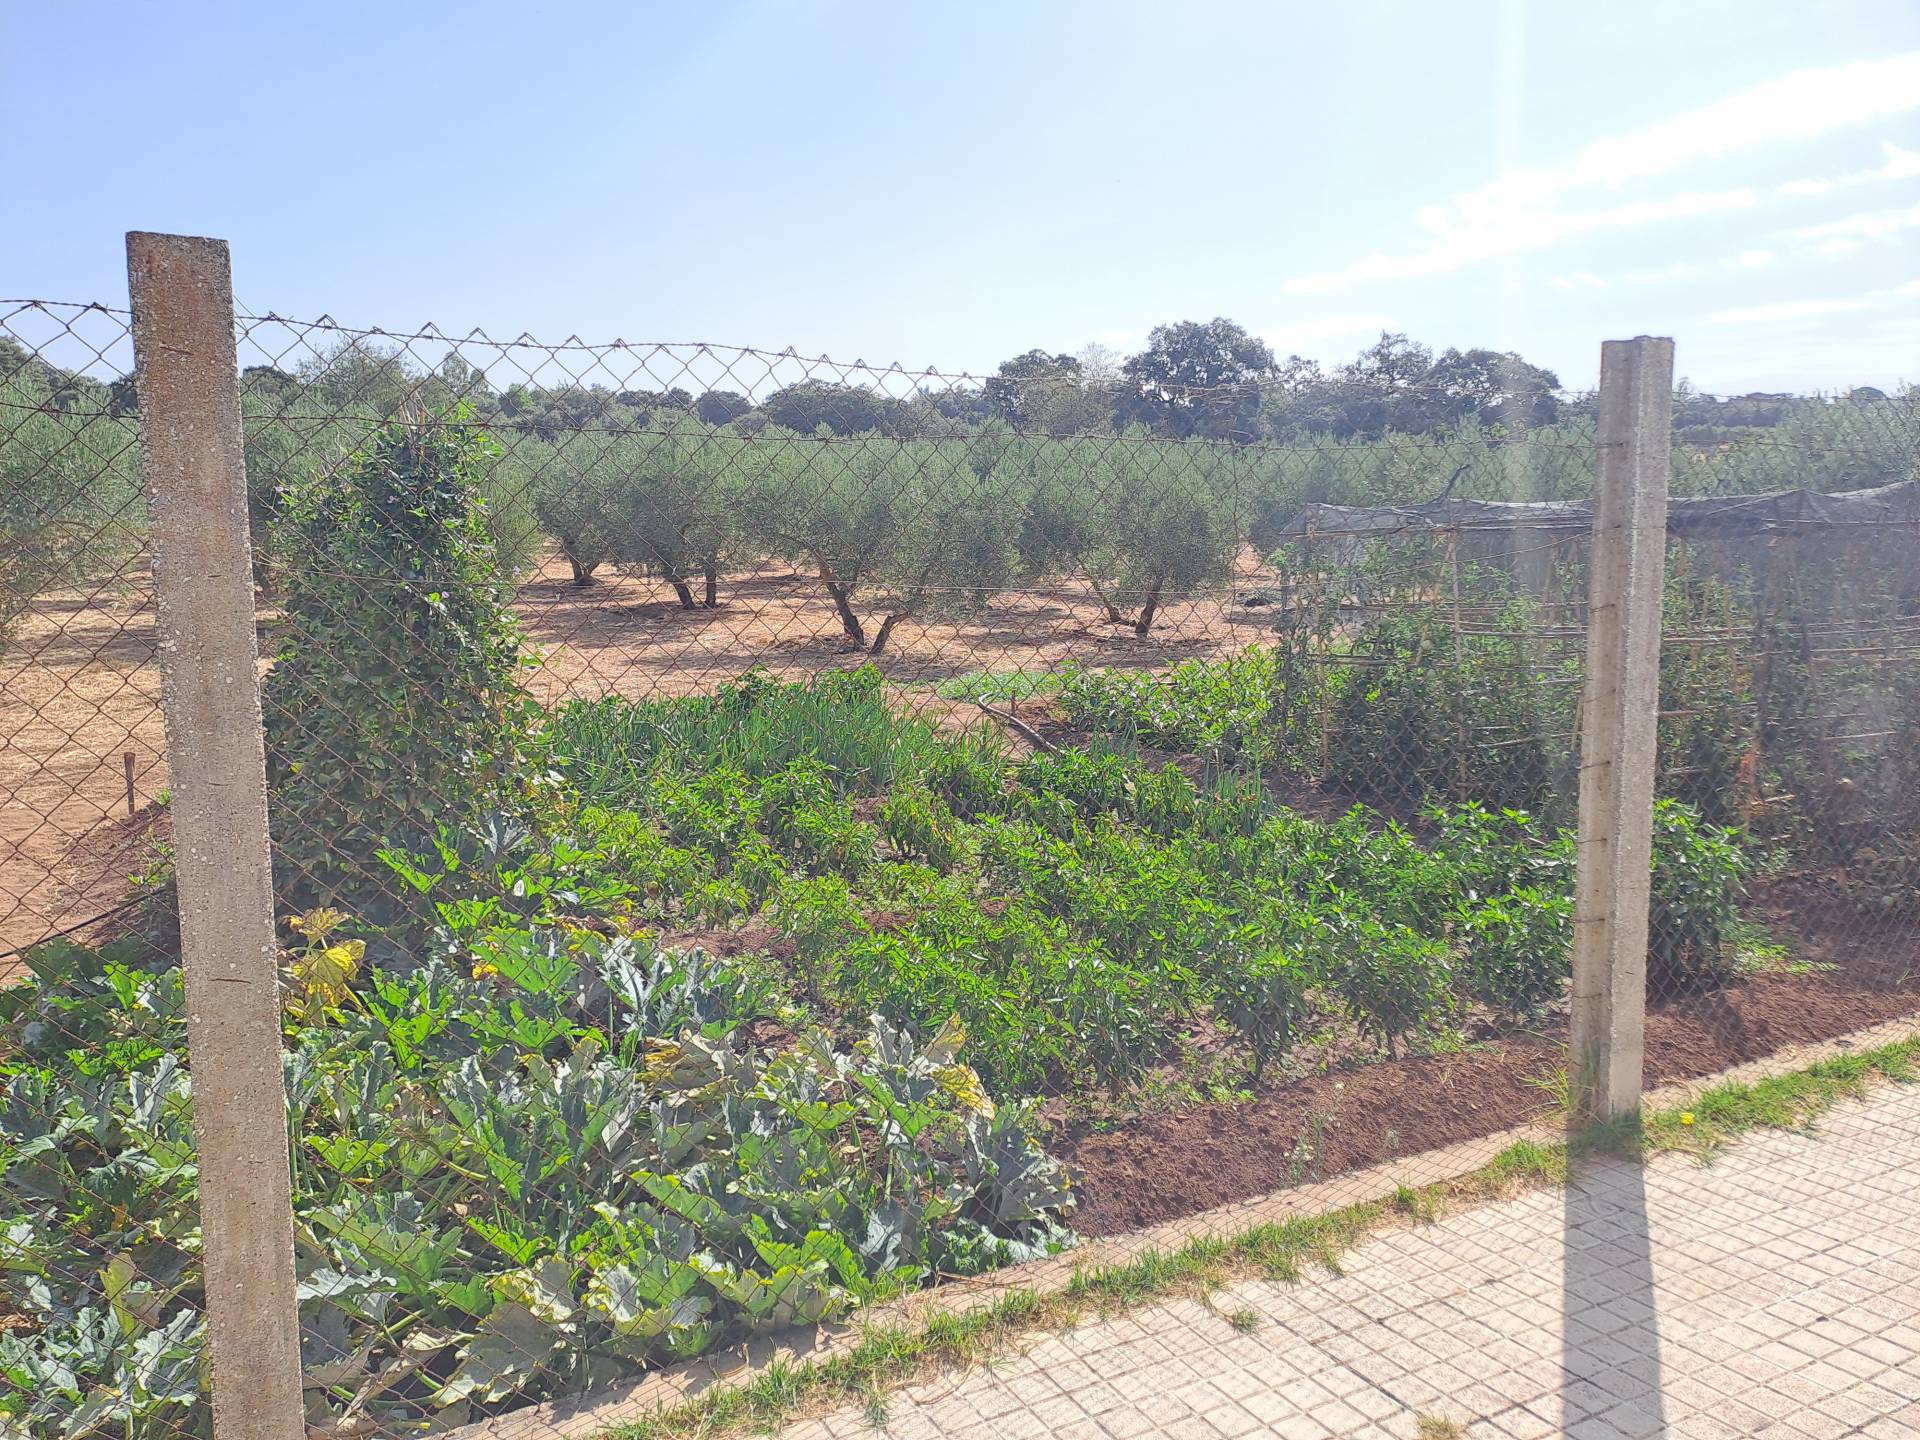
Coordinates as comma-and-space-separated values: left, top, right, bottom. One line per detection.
781, 1085, 1920, 1440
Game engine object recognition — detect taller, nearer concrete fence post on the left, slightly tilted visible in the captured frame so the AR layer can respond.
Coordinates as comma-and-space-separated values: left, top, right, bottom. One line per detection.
127, 232, 305, 1440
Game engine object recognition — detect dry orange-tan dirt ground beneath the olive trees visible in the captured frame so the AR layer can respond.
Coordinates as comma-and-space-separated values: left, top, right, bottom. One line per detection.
0, 551, 1275, 966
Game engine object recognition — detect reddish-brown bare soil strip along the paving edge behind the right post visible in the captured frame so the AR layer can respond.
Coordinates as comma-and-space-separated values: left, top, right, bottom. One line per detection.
1050, 879, 1920, 1235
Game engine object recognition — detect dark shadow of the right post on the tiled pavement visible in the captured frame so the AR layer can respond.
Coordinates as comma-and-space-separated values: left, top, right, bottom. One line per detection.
1559, 1156, 1667, 1440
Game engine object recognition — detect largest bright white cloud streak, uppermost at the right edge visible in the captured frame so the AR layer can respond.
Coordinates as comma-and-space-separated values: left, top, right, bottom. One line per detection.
1286, 52, 1920, 294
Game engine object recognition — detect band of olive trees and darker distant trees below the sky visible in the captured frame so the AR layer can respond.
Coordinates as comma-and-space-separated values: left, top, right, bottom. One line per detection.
0, 319, 1920, 653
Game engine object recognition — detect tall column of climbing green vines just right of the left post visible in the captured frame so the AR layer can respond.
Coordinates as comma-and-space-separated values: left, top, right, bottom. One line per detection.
263, 411, 530, 922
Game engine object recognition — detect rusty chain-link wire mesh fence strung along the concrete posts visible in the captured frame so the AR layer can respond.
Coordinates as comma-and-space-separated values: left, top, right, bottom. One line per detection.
0, 301, 1920, 1440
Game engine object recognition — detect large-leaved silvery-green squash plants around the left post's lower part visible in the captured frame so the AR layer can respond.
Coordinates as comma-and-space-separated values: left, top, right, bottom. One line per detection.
0, 936, 1071, 1440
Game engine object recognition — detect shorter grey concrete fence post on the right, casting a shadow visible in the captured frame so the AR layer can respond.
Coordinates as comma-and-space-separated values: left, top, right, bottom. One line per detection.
1567, 336, 1674, 1119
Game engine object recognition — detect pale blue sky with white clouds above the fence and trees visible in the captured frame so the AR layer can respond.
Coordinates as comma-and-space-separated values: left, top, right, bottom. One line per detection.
0, 0, 1920, 392
